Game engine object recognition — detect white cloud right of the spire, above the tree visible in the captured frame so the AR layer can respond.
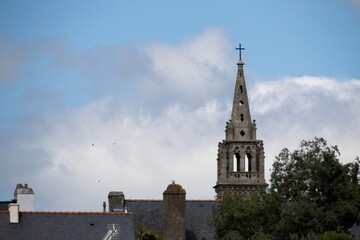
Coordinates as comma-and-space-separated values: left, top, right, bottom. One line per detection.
250, 76, 360, 180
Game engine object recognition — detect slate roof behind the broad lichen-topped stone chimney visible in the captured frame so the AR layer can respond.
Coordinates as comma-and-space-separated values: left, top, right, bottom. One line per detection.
125, 199, 215, 240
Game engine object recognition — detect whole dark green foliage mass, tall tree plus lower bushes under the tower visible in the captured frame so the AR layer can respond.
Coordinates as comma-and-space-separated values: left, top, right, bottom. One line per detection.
212, 138, 360, 240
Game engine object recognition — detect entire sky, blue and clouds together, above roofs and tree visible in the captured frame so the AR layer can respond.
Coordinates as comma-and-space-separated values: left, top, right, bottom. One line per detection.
0, 0, 360, 211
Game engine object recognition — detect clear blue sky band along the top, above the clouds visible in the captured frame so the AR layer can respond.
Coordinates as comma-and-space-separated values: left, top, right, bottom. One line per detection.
0, 0, 360, 77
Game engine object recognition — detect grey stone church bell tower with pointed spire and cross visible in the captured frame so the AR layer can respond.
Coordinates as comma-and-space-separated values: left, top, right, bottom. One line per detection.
214, 44, 266, 196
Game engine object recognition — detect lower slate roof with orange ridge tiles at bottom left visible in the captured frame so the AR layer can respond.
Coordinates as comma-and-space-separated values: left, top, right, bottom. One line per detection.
0, 211, 134, 240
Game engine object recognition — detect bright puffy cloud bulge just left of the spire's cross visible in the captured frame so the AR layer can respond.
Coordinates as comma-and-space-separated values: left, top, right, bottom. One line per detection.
147, 28, 232, 100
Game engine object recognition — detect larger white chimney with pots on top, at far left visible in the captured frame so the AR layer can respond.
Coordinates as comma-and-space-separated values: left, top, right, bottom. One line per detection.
14, 183, 35, 211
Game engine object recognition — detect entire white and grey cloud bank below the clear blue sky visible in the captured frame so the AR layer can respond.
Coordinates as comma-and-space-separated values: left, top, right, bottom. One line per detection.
0, 29, 360, 210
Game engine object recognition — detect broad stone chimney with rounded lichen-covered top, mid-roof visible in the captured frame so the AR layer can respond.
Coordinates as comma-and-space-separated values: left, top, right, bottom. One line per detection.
163, 181, 186, 240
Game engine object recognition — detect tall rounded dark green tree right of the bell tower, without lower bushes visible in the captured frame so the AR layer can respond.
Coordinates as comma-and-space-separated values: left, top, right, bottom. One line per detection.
270, 138, 360, 237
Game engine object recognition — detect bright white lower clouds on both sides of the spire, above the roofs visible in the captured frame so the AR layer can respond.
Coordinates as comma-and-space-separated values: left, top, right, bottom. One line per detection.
25, 73, 360, 210
